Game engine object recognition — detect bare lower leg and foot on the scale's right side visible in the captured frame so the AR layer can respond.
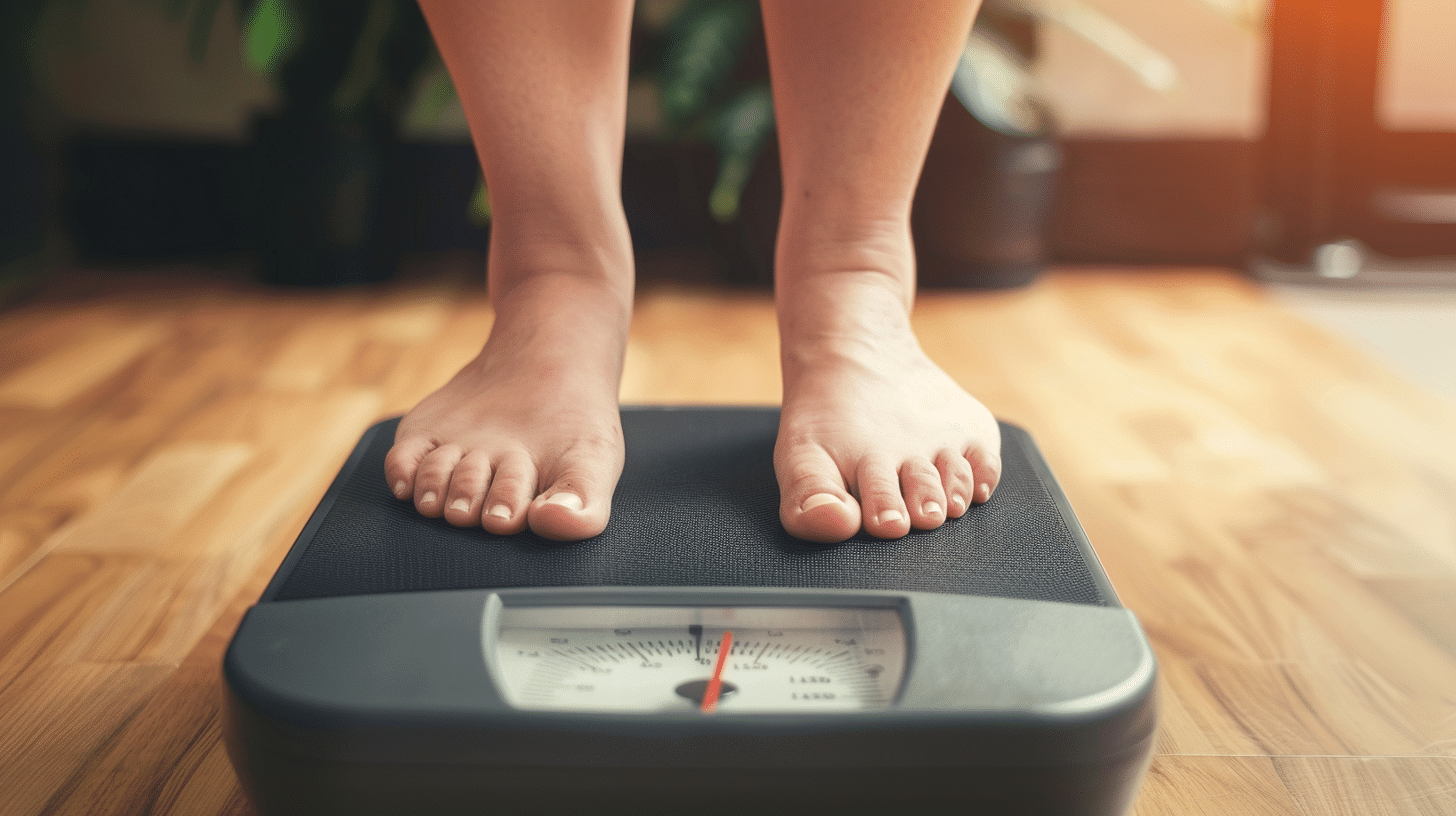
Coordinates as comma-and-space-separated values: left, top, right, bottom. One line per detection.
763, 0, 1000, 541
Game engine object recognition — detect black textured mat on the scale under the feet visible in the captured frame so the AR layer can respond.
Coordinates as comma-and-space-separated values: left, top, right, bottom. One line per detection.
264, 408, 1117, 606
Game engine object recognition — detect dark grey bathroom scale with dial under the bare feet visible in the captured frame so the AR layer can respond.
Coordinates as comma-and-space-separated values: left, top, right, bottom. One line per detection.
224, 408, 1156, 816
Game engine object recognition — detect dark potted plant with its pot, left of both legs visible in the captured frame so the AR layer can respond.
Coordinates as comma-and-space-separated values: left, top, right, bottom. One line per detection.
243, 0, 432, 286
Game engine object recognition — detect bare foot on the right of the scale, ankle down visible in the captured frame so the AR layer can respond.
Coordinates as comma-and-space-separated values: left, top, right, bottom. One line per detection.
775, 271, 1000, 542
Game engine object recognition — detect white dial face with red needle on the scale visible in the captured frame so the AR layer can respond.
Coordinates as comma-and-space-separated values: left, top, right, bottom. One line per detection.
492, 606, 906, 713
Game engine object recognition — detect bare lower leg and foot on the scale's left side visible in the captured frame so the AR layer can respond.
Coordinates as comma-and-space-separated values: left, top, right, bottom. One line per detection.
384, 0, 632, 539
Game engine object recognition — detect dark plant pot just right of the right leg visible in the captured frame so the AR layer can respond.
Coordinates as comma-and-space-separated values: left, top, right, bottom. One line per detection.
911, 95, 1061, 289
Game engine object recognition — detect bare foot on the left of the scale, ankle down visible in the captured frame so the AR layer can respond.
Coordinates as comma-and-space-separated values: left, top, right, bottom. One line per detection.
384, 274, 630, 541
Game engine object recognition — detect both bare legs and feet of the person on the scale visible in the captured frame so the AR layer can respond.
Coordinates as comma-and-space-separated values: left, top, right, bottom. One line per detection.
384, 0, 1000, 542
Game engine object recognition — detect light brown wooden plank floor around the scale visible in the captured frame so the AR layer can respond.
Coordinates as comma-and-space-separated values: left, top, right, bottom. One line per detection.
0, 259, 1456, 816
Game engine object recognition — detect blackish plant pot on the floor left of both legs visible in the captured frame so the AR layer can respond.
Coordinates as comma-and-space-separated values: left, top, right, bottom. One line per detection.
253, 117, 403, 286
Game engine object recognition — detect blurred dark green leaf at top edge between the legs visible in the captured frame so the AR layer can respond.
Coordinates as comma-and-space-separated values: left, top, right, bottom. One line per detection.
662, 0, 754, 130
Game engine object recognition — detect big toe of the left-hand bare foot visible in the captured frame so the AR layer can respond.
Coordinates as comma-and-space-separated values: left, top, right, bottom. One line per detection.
526, 446, 622, 541
